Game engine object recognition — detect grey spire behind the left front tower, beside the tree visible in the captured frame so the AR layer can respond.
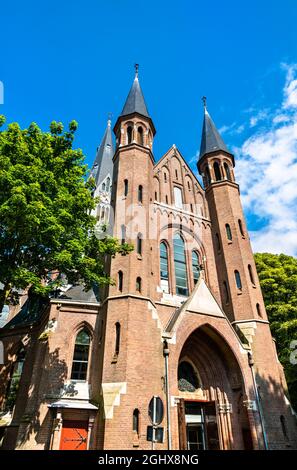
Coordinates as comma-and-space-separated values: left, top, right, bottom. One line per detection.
90, 113, 114, 186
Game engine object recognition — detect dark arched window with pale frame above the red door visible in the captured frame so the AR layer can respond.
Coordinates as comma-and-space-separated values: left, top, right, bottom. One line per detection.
71, 328, 90, 381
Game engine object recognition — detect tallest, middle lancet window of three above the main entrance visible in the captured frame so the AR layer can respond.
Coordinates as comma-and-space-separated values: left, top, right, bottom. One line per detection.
173, 233, 189, 295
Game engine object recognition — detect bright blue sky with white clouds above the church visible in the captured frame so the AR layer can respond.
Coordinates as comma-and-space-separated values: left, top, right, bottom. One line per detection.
0, 0, 297, 254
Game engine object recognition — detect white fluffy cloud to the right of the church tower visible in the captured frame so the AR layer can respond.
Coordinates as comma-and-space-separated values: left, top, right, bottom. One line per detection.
236, 65, 297, 256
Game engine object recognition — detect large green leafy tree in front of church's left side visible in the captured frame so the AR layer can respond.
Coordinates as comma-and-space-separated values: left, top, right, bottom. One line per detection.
0, 116, 131, 311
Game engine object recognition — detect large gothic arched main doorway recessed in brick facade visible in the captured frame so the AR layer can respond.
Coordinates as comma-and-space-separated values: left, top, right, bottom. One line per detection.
177, 325, 252, 450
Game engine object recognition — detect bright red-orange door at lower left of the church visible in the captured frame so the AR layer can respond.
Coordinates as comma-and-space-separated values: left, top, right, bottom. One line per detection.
60, 420, 88, 450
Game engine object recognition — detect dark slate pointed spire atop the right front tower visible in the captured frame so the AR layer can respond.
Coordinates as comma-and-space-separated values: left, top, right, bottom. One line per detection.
199, 96, 231, 158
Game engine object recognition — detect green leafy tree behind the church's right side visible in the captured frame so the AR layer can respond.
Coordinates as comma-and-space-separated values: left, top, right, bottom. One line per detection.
255, 253, 297, 409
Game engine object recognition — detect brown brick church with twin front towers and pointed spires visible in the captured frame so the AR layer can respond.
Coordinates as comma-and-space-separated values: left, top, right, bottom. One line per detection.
0, 68, 297, 450
